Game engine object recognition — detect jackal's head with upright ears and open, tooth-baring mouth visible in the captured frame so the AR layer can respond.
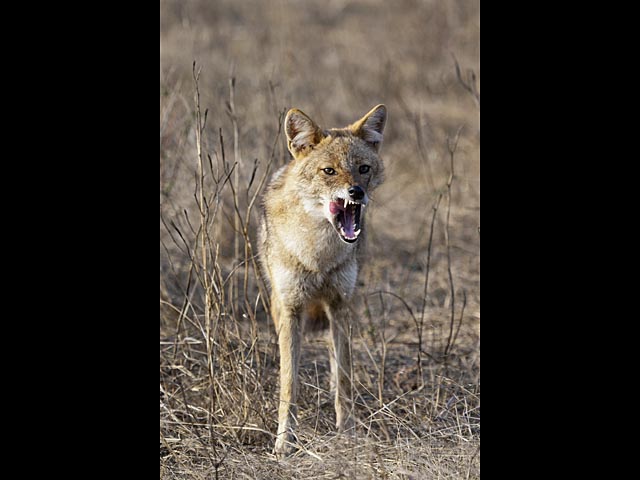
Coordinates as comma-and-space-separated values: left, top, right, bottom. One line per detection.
285, 105, 387, 243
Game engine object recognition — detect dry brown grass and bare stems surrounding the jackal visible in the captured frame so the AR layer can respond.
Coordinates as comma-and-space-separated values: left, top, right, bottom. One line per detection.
160, 0, 480, 479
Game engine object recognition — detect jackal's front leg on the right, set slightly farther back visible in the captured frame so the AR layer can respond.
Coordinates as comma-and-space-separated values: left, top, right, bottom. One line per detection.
326, 297, 352, 432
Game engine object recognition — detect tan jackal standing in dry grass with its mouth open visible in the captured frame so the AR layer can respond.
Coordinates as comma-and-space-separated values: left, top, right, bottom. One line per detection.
259, 105, 387, 457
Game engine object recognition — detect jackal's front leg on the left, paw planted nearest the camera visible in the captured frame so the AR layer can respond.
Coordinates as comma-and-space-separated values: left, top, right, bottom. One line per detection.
271, 297, 302, 458
